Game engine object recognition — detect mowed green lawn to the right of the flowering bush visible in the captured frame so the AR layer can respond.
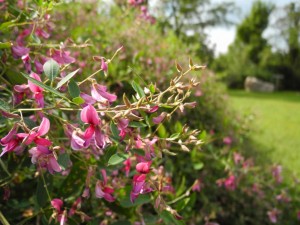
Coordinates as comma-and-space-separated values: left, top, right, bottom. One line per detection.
229, 90, 300, 177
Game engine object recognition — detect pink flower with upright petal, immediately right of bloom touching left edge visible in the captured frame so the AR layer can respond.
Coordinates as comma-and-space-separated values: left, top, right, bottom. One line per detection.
17, 117, 52, 146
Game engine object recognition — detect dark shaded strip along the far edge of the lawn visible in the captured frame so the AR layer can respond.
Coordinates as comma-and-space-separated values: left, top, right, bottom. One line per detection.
228, 90, 300, 103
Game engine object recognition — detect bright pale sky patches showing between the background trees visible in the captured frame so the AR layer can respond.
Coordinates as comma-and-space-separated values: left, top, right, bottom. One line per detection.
208, 0, 298, 55
